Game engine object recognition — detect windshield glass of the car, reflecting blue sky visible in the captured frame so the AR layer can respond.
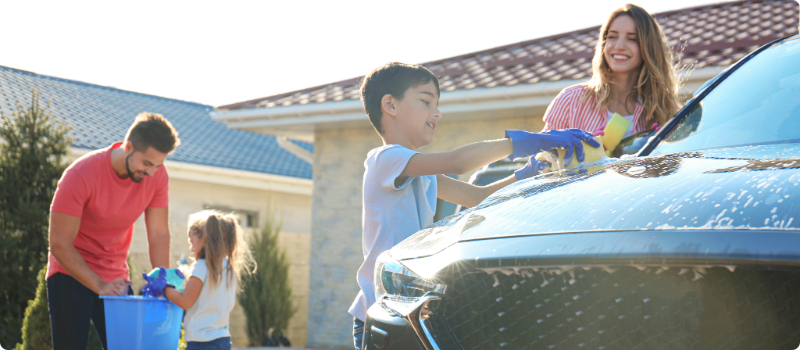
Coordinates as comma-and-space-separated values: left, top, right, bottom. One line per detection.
650, 37, 800, 155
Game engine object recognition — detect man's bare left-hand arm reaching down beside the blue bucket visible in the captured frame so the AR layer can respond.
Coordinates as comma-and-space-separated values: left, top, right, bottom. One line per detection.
50, 212, 128, 295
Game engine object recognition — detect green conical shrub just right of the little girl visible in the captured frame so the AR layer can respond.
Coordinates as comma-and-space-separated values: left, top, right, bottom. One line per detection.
237, 215, 297, 346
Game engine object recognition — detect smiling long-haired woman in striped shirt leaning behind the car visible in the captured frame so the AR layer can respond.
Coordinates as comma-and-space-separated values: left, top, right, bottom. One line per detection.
544, 4, 679, 137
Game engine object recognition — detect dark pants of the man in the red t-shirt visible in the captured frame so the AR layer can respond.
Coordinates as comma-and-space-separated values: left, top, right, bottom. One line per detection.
47, 273, 133, 350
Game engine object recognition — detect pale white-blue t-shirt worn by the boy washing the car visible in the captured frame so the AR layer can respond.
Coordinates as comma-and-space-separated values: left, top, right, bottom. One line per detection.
349, 145, 436, 321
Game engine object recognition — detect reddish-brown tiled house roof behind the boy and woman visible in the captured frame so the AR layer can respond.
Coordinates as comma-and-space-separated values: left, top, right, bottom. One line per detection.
217, 0, 798, 110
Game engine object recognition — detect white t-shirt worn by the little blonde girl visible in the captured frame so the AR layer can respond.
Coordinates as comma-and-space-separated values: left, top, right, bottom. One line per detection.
183, 259, 237, 342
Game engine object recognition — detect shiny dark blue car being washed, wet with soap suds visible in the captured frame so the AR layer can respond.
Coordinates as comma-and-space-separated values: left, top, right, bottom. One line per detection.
364, 36, 800, 350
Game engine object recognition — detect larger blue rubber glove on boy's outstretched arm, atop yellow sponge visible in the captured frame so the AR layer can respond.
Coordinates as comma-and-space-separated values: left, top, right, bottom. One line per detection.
506, 129, 600, 162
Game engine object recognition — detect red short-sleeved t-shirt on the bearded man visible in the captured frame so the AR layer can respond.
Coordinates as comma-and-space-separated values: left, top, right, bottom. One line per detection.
47, 142, 169, 282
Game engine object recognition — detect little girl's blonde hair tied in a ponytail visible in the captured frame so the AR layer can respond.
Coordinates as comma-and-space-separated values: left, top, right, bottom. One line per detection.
189, 210, 255, 286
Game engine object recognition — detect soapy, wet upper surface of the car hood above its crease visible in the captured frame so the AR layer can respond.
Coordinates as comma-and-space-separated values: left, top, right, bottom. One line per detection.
466, 154, 800, 237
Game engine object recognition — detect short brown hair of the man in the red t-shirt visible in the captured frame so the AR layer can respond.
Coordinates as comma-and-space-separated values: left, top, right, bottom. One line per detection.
125, 112, 181, 154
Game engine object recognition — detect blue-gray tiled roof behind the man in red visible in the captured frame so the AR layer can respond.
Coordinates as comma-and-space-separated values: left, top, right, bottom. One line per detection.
0, 66, 313, 179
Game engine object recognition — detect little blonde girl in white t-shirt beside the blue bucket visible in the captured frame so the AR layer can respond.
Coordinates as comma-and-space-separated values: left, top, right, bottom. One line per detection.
164, 210, 251, 350
